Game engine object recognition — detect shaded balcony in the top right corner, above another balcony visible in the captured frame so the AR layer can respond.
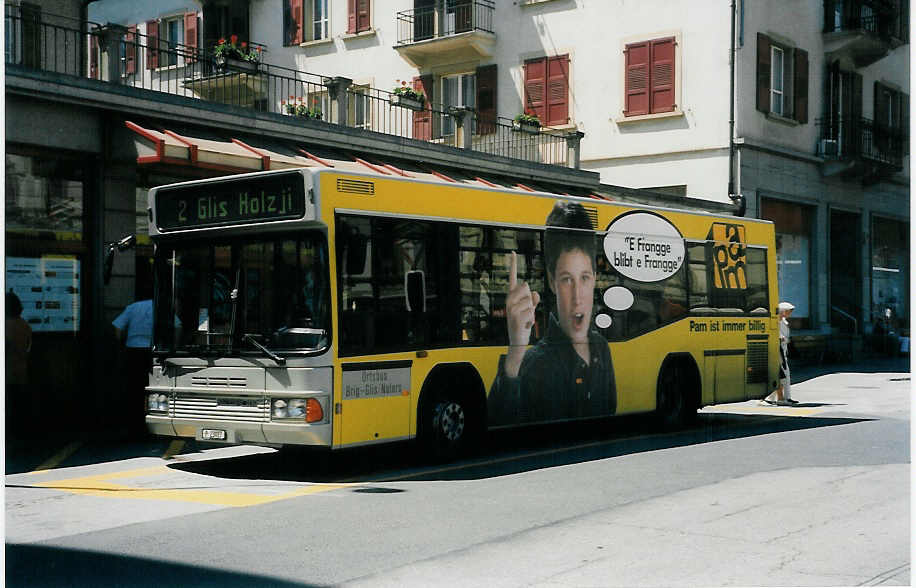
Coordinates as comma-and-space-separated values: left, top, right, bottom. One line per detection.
824, 0, 909, 68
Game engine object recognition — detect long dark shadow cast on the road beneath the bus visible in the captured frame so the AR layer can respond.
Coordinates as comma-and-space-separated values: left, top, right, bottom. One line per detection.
169, 403, 871, 483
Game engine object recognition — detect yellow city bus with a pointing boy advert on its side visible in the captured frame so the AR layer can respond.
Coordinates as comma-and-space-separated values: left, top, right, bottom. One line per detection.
146, 166, 778, 457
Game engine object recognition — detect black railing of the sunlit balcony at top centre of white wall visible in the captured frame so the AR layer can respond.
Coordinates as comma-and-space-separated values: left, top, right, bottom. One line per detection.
397, 0, 495, 45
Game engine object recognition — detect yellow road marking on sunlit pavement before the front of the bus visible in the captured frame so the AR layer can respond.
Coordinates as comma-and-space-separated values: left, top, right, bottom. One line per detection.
28, 466, 352, 507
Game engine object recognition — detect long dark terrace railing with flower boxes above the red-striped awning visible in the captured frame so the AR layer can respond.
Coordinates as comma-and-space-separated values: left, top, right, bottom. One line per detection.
5, 11, 581, 166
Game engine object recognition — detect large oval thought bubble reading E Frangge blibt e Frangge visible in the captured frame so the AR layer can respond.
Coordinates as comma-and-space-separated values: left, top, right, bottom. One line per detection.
604, 212, 686, 282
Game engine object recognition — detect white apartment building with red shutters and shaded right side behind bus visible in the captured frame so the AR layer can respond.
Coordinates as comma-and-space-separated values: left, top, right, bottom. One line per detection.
262, 0, 910, 354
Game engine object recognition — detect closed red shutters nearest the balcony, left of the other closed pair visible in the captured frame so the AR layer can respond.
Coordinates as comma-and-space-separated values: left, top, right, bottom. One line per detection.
524, 55, 569, 126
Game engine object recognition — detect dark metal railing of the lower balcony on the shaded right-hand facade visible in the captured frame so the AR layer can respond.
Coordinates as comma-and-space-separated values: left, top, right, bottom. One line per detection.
817, 117, 909, 170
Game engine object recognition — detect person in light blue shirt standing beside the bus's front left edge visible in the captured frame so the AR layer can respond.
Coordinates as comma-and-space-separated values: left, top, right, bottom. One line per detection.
111, 299, 153, 437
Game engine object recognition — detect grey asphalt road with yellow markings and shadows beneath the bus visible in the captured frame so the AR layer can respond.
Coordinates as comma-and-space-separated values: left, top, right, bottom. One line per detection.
5, 361, 911, 587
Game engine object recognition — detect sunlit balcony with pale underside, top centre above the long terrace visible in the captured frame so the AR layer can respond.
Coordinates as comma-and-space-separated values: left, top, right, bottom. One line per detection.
395, 0, 496, 69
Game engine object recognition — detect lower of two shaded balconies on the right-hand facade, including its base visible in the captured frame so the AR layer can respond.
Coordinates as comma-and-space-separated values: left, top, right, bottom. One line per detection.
817, 117, 909, 182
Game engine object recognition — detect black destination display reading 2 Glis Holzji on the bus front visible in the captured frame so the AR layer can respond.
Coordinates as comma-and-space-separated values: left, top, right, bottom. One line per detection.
154, 172, 305, 231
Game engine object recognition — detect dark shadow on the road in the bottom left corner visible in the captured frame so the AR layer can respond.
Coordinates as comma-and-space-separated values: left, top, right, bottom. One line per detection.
6, 544, 310, 588
